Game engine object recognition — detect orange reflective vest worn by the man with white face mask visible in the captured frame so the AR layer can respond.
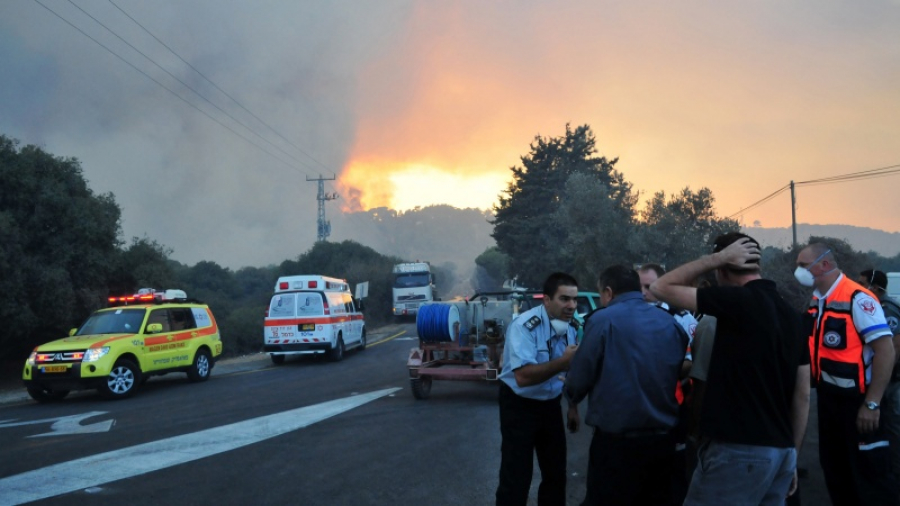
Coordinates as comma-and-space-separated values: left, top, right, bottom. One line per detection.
808, 276, 874, 393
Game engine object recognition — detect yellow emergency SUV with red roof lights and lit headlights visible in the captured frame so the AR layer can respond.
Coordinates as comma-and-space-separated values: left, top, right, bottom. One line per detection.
22, 288, 222, 402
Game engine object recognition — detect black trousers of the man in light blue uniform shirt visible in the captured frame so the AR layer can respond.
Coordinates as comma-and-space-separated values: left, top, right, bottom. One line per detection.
497, 381, 566, 506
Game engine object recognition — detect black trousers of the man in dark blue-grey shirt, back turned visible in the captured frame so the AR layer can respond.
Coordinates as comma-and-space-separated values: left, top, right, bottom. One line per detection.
581, 430, 675, 506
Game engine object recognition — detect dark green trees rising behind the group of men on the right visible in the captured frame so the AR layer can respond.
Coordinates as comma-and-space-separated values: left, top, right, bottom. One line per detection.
475, 125, 900, 309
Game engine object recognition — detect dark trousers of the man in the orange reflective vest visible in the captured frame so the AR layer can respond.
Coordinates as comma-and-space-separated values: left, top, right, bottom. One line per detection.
818, 389, 898, 506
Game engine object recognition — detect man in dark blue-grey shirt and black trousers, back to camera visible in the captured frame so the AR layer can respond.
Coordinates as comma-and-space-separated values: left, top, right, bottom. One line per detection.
565, 266, 688, 505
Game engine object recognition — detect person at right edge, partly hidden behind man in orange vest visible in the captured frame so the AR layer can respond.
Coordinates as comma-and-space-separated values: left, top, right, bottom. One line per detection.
858, 269, 900, 488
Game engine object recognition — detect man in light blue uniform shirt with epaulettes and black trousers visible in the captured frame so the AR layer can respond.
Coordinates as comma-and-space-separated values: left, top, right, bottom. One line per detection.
496, 272, 578, 506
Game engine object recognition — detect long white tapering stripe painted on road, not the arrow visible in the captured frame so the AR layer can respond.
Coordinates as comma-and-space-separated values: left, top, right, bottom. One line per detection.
0, 388, 400, 505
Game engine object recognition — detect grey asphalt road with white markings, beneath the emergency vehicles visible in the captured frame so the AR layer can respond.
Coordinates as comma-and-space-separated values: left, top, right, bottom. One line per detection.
0, 324, 829, 506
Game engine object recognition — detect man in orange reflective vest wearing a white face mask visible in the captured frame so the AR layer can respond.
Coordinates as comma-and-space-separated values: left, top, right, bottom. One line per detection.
794, 243, 898, 505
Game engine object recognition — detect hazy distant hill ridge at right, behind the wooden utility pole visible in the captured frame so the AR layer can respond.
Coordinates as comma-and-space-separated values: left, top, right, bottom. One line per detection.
743, 223, 900, 258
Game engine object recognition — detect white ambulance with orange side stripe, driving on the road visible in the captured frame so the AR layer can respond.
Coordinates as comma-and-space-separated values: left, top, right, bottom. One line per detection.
263, 275, 366, 364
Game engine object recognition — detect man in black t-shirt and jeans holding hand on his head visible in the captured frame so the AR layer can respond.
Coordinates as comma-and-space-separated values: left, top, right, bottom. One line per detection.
650, 232, 809, 505
